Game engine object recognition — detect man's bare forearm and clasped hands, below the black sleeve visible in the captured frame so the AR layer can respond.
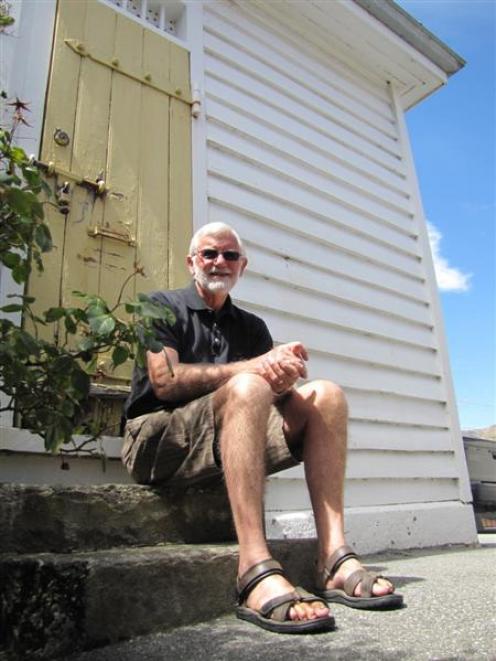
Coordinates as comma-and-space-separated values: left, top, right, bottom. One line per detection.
147, 342, 307, 402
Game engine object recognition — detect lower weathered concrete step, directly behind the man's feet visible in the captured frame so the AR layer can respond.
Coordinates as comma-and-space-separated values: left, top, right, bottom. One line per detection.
0, 540, 315, 660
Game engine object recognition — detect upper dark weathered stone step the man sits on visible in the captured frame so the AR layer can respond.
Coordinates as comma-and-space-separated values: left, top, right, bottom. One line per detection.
0, 484, 235, 553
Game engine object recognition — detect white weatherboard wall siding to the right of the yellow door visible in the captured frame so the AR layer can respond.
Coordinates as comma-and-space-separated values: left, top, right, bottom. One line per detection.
203, 2, 474, 550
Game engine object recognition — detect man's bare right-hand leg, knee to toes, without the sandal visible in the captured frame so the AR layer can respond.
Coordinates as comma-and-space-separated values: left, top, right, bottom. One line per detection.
283, 381, 392, 596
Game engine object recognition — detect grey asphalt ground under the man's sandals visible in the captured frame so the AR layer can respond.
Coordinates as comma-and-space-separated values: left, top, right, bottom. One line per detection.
70, 534, 496, 661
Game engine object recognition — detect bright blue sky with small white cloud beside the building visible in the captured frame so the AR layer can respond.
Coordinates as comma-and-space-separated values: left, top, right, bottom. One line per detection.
396, 0, 496, 429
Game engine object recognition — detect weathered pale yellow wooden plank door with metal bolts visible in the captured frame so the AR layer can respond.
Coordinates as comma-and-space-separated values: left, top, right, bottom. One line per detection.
29, 0, 192, 378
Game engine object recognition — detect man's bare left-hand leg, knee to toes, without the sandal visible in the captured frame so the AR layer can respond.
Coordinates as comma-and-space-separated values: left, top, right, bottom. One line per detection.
214, 373, 328, 620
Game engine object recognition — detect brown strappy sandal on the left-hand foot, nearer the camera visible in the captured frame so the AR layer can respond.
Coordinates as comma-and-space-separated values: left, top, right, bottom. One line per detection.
236, 558, 335, 633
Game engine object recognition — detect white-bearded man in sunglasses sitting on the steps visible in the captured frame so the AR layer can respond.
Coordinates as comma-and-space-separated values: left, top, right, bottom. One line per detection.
123, 223, 402, 632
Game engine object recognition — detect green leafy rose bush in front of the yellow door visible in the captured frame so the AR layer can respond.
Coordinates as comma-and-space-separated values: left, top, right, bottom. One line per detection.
0, 99, 174, 452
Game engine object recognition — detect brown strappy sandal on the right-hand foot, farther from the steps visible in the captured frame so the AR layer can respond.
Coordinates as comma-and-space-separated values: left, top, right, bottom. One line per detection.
315, 546, 403, 610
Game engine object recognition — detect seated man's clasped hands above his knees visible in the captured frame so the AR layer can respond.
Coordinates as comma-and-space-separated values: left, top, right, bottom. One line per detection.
254, 342, 308, 395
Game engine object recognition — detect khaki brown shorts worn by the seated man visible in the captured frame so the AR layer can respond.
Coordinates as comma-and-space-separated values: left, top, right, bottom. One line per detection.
122, 393, 301, 486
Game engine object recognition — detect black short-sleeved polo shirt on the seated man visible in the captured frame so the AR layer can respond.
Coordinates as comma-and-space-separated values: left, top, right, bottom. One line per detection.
125, 283, 273, 418
